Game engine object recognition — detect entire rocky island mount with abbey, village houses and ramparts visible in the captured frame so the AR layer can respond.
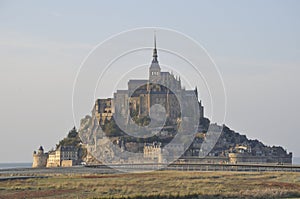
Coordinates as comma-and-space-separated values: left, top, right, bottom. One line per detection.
33, 38, 292, 167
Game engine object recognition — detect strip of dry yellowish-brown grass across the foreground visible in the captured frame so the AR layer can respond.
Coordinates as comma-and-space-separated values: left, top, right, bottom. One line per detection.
0, 171, 300, 199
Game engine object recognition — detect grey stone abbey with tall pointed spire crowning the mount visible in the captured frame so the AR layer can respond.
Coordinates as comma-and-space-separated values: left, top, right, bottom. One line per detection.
95, 38, 204, 124
